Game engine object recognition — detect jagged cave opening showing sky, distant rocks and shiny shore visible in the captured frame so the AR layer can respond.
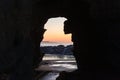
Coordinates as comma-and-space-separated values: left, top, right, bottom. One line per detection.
39, 17, 77, 80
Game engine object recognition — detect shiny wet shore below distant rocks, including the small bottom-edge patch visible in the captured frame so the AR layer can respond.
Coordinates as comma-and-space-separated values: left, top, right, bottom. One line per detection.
36, 54, 77, 80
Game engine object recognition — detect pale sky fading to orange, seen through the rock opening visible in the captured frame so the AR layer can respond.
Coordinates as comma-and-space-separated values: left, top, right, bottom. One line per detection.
43, 17, 71, 43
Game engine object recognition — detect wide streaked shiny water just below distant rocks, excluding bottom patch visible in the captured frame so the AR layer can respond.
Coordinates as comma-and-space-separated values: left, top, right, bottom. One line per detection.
37, 54, 77, 72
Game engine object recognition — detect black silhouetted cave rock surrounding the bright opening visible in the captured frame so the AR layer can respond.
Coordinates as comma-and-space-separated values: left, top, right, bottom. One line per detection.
0, 0, 120, 80
